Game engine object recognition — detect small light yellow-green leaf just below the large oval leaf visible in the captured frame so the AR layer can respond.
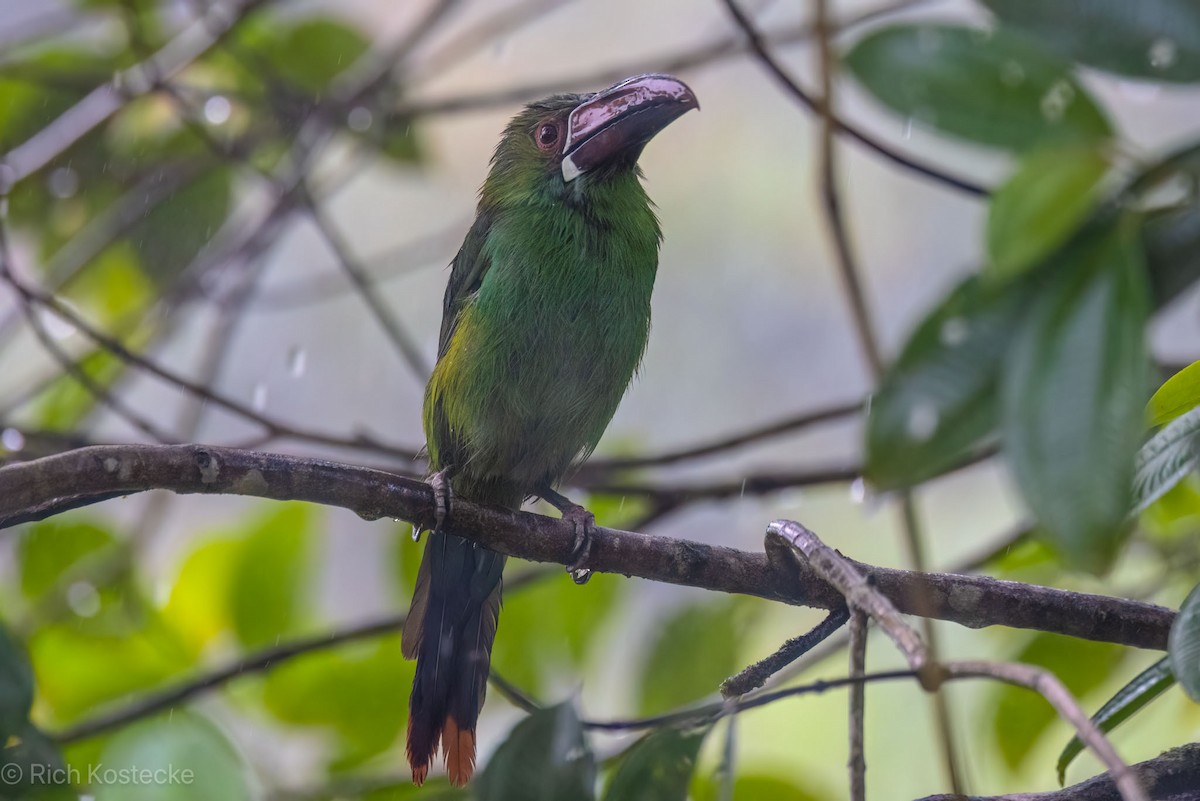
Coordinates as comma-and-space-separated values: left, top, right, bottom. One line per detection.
986, 145, 1109, 279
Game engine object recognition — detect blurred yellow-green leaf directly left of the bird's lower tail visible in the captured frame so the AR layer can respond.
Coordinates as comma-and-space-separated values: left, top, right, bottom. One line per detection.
263, 637, 413, 769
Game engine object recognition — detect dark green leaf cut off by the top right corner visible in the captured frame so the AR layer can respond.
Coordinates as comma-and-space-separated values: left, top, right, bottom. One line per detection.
983, 0, 1200, 82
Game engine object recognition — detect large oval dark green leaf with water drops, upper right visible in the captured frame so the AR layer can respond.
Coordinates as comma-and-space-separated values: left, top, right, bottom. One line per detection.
845, 24, 1112, 151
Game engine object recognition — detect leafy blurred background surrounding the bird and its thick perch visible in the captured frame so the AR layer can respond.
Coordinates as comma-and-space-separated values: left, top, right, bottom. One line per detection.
0, 0, 1200, 801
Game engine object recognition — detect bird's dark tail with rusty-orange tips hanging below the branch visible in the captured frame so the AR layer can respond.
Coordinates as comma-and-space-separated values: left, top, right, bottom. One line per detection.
402, 534, 504, 787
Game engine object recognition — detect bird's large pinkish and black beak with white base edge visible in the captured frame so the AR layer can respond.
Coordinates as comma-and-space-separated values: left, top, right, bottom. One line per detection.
563, 74, 700, 183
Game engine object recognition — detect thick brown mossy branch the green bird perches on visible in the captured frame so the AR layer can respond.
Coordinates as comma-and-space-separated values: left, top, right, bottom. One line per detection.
0, 445, 1175, 650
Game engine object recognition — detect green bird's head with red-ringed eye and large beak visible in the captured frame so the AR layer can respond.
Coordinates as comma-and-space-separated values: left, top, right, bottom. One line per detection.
482, 74, 700, 206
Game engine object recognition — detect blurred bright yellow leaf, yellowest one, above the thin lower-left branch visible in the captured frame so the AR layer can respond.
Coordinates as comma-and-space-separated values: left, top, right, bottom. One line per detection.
162, 538, 242, 656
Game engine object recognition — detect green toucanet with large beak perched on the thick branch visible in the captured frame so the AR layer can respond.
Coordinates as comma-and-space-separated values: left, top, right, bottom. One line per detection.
401, 74, 700, 787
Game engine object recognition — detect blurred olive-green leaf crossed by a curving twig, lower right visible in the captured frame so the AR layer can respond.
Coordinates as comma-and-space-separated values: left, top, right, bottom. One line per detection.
992, 633, 1124, 770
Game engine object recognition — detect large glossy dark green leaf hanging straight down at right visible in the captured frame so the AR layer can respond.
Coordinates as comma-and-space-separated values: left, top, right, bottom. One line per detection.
1002, 222, 1148, 571
